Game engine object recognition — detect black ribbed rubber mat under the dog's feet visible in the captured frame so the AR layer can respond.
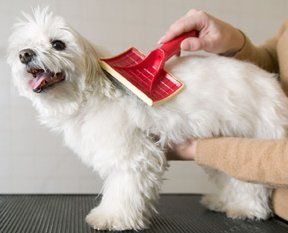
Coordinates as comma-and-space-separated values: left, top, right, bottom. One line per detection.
0, 195, 288, 233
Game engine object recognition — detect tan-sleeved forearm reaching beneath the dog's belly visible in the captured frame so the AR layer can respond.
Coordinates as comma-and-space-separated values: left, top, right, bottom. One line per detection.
194, 138, 288, 187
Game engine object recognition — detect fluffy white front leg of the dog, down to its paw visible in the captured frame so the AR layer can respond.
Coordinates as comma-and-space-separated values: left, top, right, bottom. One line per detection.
86, 137, 166, 230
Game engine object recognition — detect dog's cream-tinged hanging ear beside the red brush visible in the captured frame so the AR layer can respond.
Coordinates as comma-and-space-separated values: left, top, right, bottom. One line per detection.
79, 35, 116, 97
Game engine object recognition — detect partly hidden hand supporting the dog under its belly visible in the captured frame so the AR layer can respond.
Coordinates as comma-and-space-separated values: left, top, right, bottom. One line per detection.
167, 139, 197, 160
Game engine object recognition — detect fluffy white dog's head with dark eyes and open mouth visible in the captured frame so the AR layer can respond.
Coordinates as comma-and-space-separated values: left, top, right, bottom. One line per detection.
8, 8, 109, 108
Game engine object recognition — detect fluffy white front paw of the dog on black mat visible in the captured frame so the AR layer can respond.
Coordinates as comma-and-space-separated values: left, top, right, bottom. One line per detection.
86, 207, 145, 231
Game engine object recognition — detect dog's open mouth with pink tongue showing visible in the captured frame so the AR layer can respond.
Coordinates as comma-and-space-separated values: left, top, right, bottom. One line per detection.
27, 68, 65, 93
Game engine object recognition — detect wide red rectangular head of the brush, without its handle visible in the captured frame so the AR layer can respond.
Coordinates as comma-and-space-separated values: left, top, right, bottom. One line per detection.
99, 47, 184, 106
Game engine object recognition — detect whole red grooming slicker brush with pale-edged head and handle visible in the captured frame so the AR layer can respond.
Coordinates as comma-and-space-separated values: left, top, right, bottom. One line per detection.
99, 31, 198, 106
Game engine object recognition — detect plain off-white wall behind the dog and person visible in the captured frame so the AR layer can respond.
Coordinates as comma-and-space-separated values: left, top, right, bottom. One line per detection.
0, 0, 288, 193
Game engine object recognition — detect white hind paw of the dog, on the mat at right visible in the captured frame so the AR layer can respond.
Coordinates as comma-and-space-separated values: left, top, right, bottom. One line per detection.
225, 207, 271, 220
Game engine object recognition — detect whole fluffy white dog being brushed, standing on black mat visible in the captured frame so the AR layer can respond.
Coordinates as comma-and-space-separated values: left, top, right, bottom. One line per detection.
8, 9, 288, 230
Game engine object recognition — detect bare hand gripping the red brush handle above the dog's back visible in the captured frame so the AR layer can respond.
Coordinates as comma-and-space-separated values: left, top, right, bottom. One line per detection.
158, 9, 245, 55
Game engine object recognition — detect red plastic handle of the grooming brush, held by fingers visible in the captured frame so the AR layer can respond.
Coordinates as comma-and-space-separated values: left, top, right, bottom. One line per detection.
158, 30, 199, 61
